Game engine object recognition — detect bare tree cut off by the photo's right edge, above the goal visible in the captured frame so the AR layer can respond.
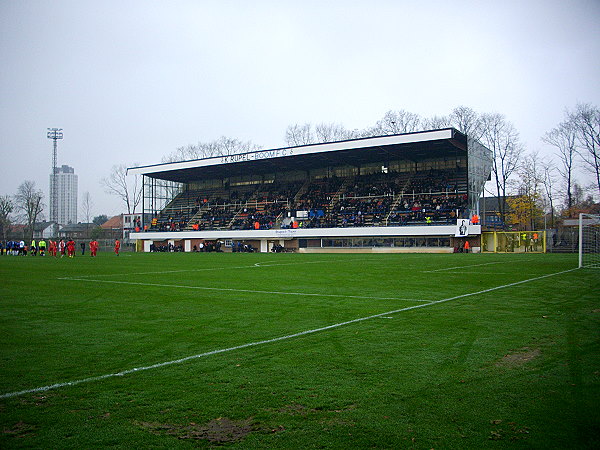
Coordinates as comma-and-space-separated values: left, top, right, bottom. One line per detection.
569, 103, 600, 199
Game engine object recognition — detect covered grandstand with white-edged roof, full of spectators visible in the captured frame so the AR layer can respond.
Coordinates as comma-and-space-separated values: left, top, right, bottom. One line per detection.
128, 128, 491, 252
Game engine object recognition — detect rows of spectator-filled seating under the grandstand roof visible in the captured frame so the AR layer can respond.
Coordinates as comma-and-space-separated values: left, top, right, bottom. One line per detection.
149, 169, 467, 231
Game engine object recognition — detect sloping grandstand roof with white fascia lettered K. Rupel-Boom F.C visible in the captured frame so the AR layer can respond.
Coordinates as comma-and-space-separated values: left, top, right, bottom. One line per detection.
127, 128, 467, 183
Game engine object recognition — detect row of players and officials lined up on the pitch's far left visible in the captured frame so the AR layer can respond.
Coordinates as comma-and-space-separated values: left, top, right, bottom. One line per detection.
0, 239, 121, 258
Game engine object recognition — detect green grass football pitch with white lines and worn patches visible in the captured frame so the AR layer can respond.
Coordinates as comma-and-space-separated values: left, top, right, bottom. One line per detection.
0, 253, 600, 449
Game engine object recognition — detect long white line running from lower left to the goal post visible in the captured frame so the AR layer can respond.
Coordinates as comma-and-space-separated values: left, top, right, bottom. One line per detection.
0, 268, 578, 399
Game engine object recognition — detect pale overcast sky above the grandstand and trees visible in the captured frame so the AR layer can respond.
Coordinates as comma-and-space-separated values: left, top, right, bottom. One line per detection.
0, 0, 600, 219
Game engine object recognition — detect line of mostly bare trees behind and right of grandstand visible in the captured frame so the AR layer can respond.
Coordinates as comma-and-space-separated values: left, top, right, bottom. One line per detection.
151, 103, 600, 227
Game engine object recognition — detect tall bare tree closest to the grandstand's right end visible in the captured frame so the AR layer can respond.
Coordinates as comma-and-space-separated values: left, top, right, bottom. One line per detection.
481, 113, 523, 222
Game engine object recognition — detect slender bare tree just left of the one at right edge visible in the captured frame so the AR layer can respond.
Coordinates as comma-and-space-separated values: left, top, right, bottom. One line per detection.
542, 121, 577, 209
